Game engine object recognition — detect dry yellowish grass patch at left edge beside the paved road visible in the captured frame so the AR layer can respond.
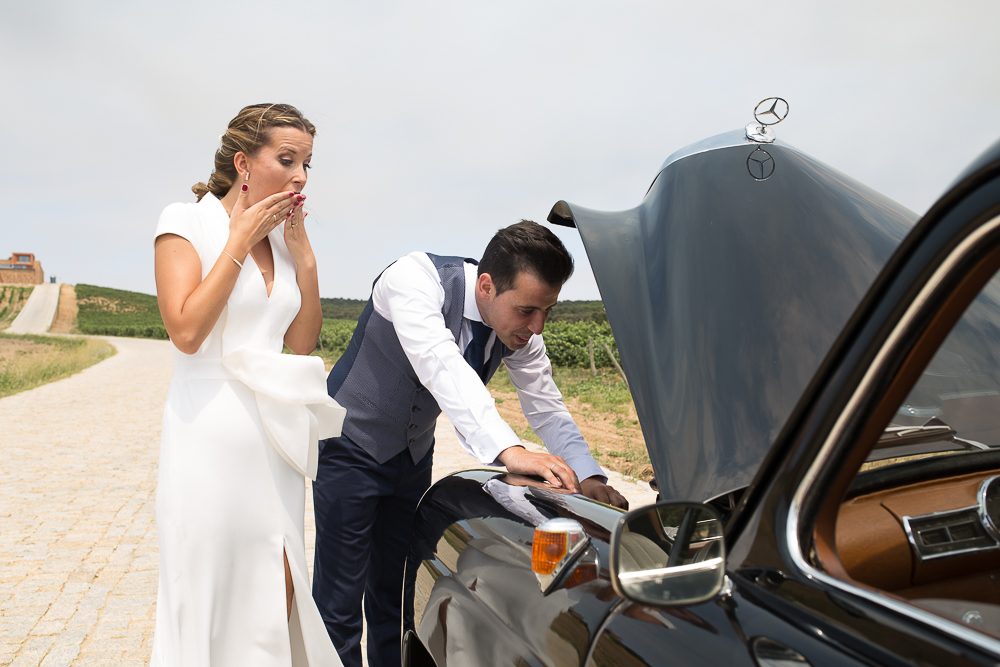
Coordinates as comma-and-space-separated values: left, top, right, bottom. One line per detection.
0, 334, 115, 397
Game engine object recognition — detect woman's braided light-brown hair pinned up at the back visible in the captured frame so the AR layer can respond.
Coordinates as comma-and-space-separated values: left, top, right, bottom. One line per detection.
191, 104, 316, 201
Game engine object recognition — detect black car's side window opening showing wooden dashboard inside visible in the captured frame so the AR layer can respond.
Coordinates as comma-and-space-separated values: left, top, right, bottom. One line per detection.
835, 264, 1000, 637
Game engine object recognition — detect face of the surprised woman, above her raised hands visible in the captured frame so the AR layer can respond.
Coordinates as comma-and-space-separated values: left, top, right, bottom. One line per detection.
247, 127, 312, 205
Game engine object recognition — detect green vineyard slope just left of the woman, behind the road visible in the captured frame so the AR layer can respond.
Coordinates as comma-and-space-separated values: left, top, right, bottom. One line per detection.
76, 285, 167, 340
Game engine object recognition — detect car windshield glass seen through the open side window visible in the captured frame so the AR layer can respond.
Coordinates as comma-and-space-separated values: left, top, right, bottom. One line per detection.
868, 274, 1000, 467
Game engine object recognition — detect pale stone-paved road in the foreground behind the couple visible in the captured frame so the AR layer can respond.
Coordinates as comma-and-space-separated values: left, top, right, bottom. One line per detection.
0, 338, 652, 667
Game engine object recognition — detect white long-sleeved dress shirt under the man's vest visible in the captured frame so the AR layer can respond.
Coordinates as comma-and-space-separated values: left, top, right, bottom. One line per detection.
372, 252, 607, 481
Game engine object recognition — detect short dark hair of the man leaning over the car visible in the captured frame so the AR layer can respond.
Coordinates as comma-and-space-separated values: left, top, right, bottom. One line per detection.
478, 220, 573, 294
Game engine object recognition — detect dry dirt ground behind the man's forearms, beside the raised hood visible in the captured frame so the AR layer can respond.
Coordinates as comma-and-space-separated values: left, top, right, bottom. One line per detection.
490, 388, 653, 482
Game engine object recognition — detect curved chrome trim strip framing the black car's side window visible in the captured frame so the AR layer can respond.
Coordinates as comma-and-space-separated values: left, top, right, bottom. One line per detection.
785, 216, 1000, 655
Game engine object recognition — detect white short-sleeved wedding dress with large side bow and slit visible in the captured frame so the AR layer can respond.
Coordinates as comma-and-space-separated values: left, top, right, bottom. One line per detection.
150, 194, 344, 667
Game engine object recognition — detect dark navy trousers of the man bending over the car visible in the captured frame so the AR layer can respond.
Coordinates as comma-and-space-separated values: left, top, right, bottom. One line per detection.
313, 437, 434, 667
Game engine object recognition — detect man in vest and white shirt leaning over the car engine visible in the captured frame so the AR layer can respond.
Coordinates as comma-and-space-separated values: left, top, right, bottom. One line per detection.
313, 220, 628, 667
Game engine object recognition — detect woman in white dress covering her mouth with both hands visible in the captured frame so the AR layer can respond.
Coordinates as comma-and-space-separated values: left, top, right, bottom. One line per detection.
151, 104, 344, 667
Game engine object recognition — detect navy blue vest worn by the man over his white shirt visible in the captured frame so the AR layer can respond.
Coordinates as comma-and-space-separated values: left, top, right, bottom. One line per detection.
326, 253, 512, 463
